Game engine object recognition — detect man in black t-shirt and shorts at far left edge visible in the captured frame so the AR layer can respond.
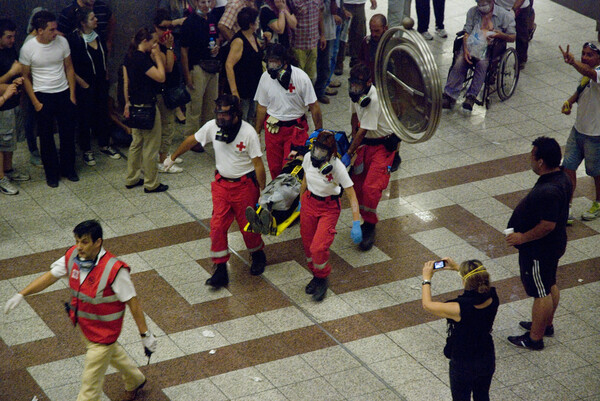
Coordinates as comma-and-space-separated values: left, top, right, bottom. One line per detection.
0, 18, 30, 195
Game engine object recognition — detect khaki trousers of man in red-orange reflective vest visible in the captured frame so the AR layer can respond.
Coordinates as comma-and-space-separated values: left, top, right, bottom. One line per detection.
77, 332, 146, 401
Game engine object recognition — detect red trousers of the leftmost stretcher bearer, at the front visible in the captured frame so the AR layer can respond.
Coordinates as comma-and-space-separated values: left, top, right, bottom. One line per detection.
210, 176, 264, 263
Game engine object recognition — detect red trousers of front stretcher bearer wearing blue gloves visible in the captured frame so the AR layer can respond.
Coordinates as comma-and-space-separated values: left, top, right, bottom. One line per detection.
300, 191, 341, 278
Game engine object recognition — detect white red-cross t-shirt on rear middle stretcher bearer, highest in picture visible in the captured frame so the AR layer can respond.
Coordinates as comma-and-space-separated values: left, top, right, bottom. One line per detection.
254, 66, 317, 121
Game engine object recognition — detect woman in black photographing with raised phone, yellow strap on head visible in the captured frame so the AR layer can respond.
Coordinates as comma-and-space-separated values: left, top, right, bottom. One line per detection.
422, 258, 500, 401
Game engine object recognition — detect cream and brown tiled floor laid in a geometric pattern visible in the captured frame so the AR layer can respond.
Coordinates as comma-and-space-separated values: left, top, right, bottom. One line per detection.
0, 0, 600, 401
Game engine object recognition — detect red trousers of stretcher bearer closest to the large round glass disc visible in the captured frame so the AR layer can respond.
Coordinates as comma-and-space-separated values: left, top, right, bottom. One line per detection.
352, 145, 394, 224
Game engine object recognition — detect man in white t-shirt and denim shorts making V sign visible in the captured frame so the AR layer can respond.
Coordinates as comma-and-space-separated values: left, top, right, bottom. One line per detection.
559, 42, 600, 219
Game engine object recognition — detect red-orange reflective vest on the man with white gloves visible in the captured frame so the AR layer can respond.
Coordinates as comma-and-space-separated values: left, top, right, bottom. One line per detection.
65, 246, 129, 344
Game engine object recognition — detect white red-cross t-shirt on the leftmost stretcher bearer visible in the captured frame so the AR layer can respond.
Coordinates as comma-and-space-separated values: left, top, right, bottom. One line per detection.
194, 120, 262, 178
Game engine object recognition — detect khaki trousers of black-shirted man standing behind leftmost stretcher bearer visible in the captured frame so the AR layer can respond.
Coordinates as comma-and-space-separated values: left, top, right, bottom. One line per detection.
185, 65, 219, 135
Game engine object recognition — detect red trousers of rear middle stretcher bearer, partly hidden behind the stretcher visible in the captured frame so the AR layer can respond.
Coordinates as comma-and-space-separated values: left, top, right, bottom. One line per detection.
264, 116, 308, 179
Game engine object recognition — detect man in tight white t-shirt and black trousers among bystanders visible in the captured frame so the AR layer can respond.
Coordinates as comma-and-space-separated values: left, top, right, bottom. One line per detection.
19, 10, 79, 188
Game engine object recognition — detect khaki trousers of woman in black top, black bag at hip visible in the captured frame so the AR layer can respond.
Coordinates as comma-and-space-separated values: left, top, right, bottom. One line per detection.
125, 106, 161, 190
